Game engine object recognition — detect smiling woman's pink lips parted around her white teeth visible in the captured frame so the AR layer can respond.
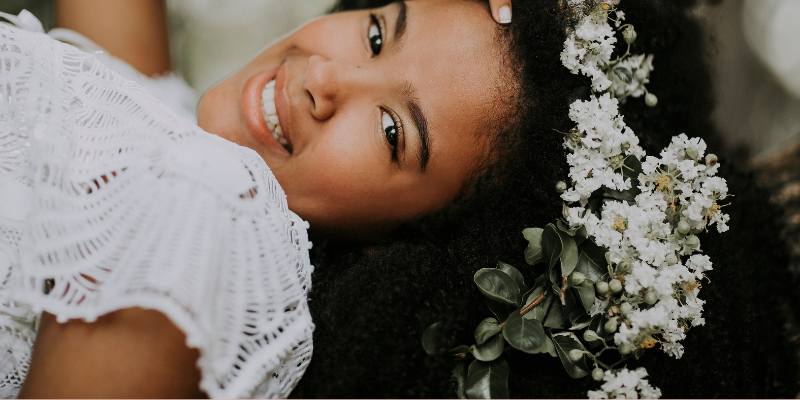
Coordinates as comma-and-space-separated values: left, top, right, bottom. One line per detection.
242, 68, 290, 156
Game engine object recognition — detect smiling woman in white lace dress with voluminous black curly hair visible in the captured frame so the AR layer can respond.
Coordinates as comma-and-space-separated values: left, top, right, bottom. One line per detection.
0, 0, 798, 398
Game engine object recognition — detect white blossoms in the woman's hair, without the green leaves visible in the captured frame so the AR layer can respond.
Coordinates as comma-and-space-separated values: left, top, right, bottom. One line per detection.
562, 2, 729, 398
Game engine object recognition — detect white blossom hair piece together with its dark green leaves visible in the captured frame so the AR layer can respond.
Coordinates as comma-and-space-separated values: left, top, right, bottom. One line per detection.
422, 0, 729, 398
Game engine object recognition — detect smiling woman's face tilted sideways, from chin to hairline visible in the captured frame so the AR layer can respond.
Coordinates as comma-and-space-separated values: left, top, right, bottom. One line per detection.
198, 0, 503, 236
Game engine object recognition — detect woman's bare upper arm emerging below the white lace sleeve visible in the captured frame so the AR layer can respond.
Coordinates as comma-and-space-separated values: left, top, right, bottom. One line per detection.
19, 308, 206, 398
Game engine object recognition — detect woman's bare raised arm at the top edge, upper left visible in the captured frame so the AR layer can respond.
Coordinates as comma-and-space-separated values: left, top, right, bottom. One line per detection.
56, 0, 170, 76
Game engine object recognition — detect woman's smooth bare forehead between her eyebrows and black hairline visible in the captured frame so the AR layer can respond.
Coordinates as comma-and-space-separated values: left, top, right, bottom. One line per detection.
388, 0, 505, 163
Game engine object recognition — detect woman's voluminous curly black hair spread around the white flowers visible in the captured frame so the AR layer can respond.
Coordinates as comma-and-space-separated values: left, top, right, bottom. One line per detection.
292, 0, 800, 397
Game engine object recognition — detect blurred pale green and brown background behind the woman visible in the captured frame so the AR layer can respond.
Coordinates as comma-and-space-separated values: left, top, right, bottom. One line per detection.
0, 0, 800, 270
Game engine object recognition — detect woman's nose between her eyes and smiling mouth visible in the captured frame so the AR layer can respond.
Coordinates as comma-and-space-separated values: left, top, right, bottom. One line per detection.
304, 54, 355, 120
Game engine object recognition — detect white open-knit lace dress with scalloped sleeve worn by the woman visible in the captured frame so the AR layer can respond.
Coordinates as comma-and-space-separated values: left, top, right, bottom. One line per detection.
0, 10, 314, 398
